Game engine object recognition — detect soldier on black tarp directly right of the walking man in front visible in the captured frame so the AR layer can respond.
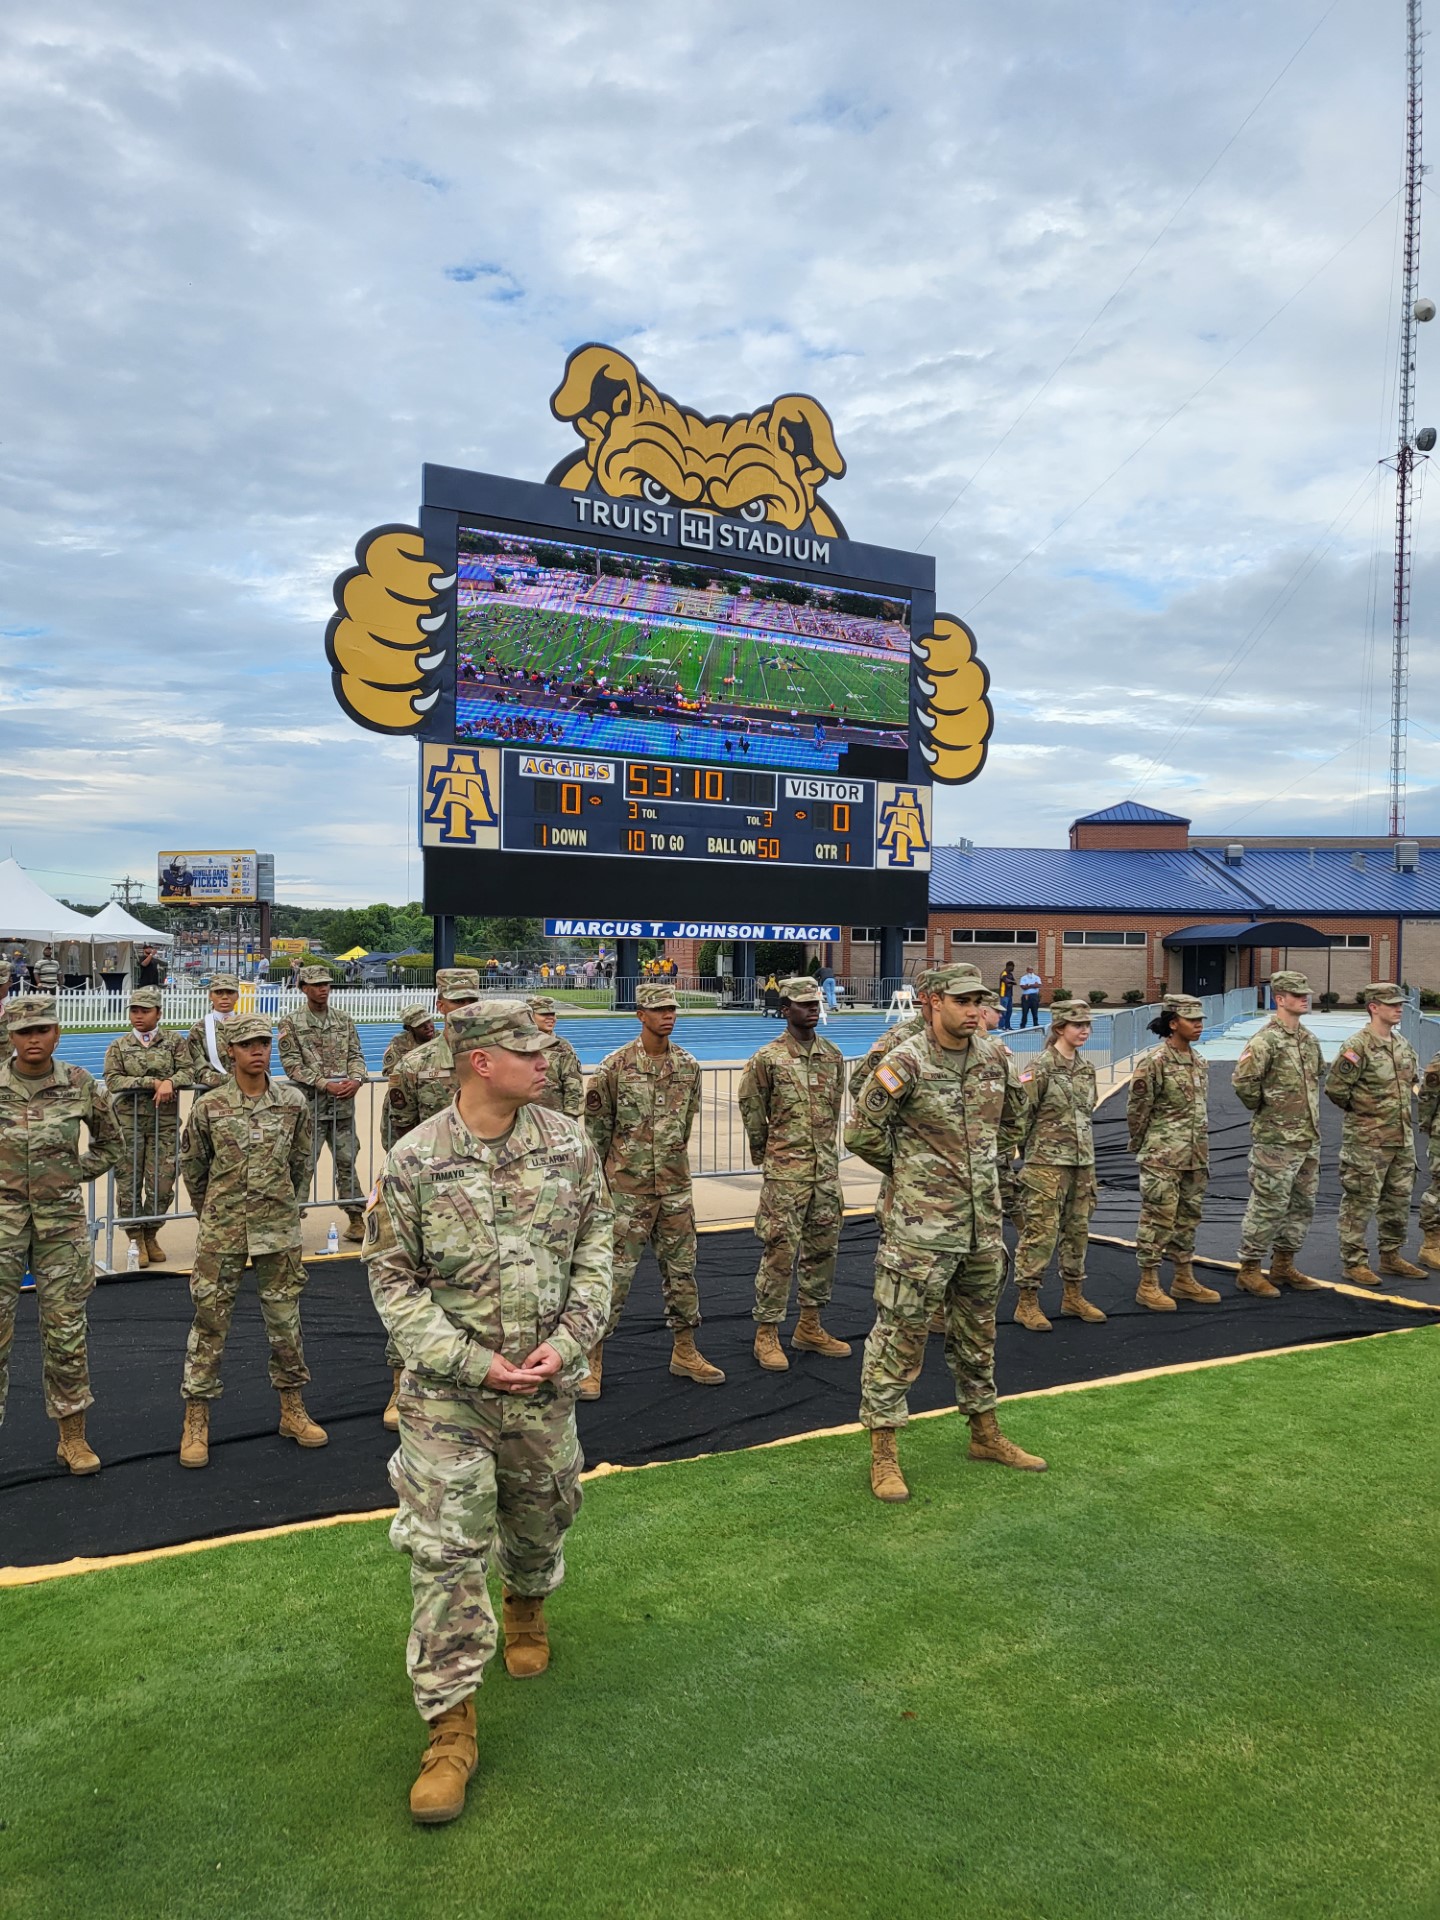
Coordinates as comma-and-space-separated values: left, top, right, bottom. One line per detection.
580, 981, 724, 1400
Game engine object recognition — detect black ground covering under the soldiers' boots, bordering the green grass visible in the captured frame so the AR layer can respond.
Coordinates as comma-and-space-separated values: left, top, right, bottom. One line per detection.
0, 1219, 1436, 1567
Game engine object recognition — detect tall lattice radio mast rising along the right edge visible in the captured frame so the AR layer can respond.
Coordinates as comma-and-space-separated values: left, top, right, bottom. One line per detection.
1390, 0, 1434, 835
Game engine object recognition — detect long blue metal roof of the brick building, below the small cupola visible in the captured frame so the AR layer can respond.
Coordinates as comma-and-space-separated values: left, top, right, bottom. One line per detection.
929, 844, 1440, 922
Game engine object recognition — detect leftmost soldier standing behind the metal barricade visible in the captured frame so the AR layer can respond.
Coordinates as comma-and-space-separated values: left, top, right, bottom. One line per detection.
106, 987, 190, 1267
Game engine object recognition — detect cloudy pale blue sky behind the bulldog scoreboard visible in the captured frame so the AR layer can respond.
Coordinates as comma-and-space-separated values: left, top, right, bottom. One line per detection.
0, 0, 1440, 904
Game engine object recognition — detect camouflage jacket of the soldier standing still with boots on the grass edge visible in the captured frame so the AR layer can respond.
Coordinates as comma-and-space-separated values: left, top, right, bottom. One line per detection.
845, 1033, 1025, 1254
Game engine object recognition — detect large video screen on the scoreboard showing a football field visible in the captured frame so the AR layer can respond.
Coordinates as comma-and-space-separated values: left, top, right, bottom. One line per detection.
455, 528, 910, 772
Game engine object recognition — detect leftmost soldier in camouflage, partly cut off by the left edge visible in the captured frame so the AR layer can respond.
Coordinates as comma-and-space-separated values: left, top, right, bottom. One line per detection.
0, 996, 123, 1473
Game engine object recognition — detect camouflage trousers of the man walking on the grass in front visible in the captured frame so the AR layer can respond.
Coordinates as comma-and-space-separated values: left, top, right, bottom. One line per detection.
390, 1373, 584, 1720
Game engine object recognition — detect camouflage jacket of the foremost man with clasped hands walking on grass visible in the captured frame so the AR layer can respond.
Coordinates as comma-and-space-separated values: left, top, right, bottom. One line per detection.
365, 1102, 612, 1400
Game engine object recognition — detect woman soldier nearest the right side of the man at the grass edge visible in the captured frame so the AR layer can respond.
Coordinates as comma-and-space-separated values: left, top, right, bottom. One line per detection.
1016, 1000, 1104, 1332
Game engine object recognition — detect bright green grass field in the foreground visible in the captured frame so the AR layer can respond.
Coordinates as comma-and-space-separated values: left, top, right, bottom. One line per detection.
0, 1331, 1440, 1920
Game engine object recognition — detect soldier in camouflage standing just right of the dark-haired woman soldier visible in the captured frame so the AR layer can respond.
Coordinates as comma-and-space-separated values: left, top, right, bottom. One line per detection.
1231, 972, 1325, 1300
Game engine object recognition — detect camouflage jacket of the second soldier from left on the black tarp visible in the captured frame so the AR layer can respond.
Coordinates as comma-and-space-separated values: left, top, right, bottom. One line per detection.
180, 1079, 311, 1260
